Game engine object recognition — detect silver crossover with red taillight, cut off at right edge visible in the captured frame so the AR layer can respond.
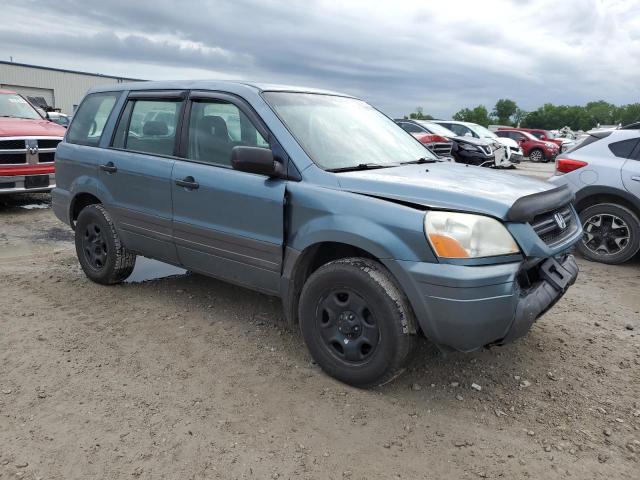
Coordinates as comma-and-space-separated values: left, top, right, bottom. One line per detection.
550, 129, 640, 264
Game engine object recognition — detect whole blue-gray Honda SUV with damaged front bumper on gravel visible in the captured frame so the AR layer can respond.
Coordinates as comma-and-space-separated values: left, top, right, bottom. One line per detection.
53, 81, 582, 386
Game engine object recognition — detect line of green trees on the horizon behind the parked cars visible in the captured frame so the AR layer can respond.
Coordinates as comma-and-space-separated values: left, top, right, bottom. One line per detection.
405, 98, 640, 130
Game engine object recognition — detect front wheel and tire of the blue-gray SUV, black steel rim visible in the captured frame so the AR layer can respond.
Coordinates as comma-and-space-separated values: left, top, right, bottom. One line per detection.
299, 257, 417, 387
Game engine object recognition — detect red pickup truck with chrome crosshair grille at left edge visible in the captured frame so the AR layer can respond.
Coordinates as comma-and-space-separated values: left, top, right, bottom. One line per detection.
0, 90, 66, 195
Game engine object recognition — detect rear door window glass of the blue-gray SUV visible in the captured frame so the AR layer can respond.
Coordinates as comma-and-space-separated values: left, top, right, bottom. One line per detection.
112, 99, 182, 156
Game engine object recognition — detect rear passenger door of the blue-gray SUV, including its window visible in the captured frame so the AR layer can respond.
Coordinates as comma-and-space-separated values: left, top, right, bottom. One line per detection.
99, 91, 186, 263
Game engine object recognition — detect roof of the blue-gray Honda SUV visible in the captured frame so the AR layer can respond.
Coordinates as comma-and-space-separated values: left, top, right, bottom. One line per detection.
90, 80, 351, 97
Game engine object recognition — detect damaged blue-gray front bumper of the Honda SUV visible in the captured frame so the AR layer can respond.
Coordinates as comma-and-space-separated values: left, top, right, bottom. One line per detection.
387, 255, 578, 351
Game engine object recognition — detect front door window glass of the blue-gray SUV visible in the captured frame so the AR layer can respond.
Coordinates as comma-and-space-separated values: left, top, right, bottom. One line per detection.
187, 100, 269, 166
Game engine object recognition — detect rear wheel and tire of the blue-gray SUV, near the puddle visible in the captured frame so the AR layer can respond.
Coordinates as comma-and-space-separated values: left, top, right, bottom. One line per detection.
75, 205, 136, 285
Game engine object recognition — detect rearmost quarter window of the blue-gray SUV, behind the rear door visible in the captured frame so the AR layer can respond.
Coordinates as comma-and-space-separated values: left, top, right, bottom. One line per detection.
66, 92, 120, 147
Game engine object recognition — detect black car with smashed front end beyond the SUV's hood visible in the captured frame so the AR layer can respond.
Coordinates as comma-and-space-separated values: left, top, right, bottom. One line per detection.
396, 120, 511, 167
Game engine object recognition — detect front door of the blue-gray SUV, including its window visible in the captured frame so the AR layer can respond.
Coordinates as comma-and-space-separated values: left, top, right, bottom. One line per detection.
171, 90, 286, 293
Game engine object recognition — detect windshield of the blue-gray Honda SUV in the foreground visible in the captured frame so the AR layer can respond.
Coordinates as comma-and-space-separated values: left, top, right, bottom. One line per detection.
264, 92, 437, 170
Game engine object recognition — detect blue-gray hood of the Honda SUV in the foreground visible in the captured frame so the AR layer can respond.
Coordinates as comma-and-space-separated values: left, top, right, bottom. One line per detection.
338, 162, 555, 219
